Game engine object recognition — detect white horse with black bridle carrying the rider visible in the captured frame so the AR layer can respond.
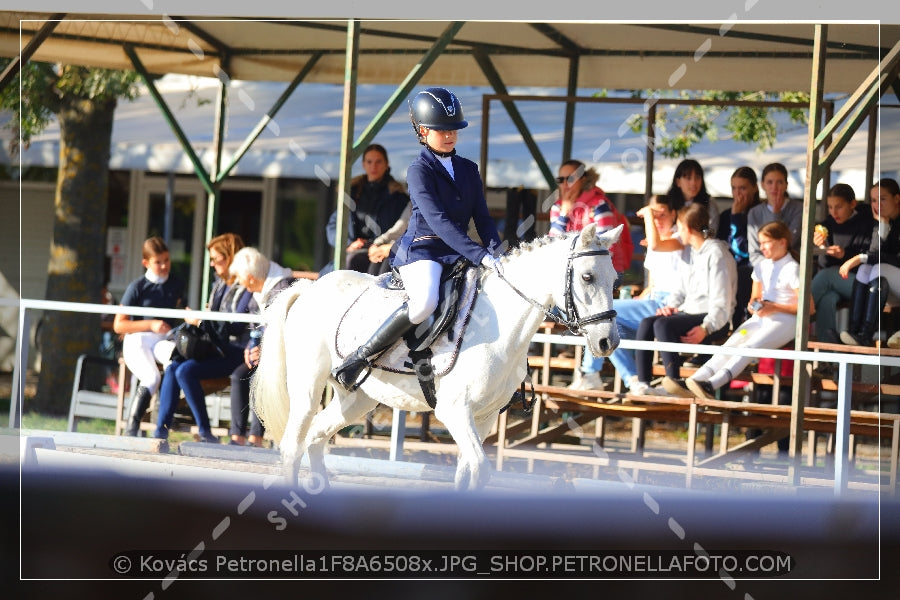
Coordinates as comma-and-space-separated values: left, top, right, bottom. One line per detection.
252, 225, 622, 489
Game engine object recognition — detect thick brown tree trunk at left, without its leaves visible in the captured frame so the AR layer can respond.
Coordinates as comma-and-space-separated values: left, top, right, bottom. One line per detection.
30, 100, 116, 414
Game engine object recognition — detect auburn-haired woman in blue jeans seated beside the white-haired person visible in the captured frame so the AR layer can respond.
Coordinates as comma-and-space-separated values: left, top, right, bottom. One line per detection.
154, 233, 253, 443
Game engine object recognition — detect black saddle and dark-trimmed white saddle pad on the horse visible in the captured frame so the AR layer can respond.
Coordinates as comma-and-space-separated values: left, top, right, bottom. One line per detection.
335, 259, 480, 379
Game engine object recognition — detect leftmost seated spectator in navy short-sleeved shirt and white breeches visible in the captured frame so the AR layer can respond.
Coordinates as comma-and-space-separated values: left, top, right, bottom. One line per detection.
113, 236, 184, 436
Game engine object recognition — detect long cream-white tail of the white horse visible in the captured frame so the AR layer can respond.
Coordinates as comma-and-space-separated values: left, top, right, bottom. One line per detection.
250, 279, 312, 443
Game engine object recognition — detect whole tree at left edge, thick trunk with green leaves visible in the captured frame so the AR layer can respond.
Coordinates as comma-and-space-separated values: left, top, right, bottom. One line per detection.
0, 61, 139, 413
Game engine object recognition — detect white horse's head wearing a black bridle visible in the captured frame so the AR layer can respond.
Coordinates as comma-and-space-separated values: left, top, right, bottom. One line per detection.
564, 223, 623, 356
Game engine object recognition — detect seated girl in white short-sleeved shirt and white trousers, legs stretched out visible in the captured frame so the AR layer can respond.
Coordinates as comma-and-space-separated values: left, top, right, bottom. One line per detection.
685, 221, 800, 399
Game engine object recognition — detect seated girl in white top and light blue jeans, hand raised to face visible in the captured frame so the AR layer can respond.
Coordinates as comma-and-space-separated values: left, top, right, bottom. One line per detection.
569, 196, 685, 394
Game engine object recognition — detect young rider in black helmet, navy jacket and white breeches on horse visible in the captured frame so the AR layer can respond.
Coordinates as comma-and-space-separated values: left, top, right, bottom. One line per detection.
331, 88, 501, 390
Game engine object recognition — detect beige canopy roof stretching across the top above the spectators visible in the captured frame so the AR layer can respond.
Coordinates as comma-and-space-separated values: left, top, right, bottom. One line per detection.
0, 11, 900, 93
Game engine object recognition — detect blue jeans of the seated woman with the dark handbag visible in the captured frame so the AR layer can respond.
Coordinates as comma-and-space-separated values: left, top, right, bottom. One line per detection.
153, 344, 244, 439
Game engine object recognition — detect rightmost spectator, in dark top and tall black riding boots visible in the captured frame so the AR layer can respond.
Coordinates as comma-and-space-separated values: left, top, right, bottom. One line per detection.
839, 179, 900, 346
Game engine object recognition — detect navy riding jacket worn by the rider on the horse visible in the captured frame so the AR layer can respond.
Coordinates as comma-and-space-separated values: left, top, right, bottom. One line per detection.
391, 148, 500, 267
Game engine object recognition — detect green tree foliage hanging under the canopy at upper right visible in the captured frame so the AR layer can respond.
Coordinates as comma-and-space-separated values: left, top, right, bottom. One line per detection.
630, 90, 809, 158
